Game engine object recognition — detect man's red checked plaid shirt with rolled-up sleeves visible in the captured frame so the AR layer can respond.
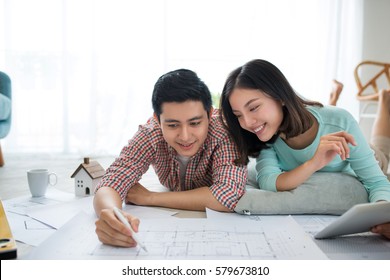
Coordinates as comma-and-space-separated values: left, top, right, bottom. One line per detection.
96, 110, 247, 210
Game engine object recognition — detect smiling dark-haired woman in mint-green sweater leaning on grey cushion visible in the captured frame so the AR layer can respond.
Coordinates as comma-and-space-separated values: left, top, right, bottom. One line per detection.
220, 59, 390, 238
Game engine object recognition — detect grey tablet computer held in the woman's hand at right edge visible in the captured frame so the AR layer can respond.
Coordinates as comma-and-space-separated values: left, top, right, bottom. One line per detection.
314, 201, 390, 239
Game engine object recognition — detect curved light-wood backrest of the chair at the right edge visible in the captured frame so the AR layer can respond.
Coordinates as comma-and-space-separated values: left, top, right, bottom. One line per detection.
354, 60, 390, 101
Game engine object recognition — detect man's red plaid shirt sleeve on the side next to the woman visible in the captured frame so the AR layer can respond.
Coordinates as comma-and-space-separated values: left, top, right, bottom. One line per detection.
210, 136, 248, 211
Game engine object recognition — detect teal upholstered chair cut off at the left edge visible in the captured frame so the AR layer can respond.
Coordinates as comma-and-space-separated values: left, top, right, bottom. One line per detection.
0, 72, 12, 167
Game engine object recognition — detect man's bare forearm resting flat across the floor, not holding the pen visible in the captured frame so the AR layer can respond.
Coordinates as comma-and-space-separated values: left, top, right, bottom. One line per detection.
126, 184, 231, 212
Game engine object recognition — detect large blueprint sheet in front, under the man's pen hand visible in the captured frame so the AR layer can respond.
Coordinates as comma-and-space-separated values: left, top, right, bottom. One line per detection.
25, 212, 327, 260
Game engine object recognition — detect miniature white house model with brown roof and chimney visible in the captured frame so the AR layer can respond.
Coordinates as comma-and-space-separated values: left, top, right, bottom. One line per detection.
70, 158, 105, 196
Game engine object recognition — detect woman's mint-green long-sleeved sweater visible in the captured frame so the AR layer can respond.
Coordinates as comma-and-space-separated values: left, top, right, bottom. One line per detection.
256, 108, 390, 202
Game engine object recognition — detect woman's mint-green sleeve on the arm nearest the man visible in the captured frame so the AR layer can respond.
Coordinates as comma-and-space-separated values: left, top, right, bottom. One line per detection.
256, 147, 282, 192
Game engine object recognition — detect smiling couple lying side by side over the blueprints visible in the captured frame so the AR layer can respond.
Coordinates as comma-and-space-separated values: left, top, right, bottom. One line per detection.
94, 60, 390, 247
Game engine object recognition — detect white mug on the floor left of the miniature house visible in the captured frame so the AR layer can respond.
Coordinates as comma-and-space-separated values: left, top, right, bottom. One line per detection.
27, 169, 57, 196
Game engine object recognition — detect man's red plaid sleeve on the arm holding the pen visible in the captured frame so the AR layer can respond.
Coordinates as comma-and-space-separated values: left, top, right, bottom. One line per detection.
95, 126, 155, 201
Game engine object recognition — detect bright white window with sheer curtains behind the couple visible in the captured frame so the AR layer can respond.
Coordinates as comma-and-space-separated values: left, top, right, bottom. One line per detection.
0, 0, 362, 154
